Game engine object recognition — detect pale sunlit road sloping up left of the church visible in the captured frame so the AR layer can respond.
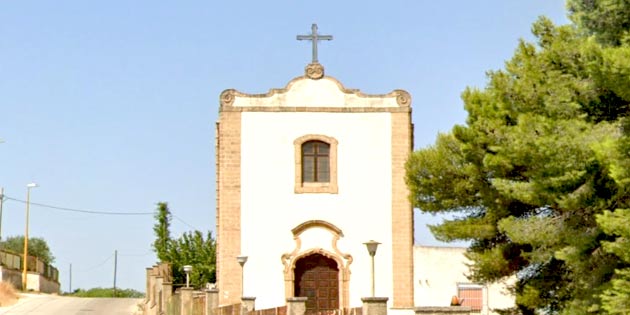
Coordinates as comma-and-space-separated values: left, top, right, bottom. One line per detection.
0, 294, 142, 315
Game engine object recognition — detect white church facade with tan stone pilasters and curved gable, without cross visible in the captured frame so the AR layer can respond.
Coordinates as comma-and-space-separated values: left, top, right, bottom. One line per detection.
216, 62, 414, 311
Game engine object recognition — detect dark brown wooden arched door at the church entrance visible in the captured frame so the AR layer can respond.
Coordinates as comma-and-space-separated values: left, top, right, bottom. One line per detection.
294, 254, 339, 313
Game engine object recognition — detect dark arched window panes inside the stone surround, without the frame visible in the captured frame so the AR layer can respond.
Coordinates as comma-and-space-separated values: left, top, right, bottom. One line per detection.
302, 141, 330, 183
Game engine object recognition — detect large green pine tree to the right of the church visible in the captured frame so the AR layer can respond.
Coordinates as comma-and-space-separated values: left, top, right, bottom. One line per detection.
406, 0, 630, 315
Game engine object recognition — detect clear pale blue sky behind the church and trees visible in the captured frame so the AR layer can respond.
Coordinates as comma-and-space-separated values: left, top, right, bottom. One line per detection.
0, 0, 568, 291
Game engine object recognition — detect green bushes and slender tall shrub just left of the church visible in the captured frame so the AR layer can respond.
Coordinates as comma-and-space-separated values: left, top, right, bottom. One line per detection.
153, 202, 216, 288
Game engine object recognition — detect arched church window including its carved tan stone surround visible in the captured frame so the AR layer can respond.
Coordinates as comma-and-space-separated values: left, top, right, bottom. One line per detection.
293, 135, 337, 194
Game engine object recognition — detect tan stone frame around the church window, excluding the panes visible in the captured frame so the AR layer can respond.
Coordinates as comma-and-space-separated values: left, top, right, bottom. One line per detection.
293, 134, 339, 194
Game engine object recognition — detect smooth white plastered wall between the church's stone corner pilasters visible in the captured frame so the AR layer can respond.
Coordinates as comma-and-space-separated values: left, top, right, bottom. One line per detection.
241, 112, 392, 309
